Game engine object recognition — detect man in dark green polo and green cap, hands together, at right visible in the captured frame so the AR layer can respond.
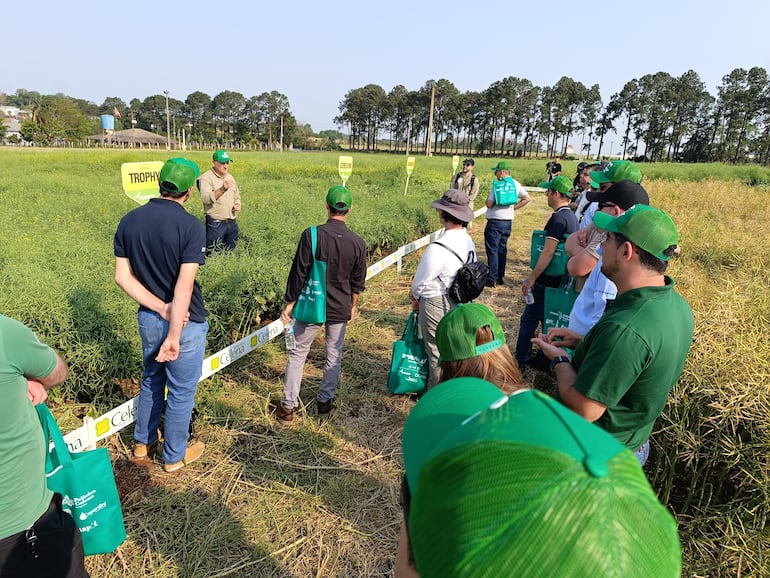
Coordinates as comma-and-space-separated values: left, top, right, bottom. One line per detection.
532, 205, 694, 464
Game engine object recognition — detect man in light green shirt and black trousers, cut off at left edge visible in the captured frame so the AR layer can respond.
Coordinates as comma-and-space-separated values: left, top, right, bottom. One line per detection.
0, 315, 88, 578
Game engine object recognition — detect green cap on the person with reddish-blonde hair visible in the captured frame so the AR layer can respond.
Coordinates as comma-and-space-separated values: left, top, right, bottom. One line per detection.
436, 303, 505, 361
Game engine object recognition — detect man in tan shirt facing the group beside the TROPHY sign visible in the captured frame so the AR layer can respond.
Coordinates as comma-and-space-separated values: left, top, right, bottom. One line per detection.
198, 149, 241, 253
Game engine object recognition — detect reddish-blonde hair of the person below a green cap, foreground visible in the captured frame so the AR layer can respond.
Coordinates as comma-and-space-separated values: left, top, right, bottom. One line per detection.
441, 326, 527, 394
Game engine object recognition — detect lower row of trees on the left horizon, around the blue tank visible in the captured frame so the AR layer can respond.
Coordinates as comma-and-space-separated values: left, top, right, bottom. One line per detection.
0, 89, 341, 149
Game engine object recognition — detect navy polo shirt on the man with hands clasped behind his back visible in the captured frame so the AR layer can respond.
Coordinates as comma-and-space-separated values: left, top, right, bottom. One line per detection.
114, 198, 208, 323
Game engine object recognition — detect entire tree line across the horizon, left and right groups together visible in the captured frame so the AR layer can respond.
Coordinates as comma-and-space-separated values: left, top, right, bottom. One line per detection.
0, 67, 770, 164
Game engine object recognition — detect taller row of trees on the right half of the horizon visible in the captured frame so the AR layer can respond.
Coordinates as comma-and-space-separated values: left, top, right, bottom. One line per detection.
334, 67, 770, 164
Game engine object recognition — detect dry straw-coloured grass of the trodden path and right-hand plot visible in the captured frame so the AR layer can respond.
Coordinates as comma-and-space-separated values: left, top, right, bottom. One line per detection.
82, 182, 770, 578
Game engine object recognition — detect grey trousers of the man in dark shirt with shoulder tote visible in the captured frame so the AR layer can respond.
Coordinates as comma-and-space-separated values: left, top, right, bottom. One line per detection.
282, 321, 348, 408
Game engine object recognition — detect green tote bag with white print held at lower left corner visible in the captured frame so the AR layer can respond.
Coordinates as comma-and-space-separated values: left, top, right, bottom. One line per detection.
35, 403, 126, 556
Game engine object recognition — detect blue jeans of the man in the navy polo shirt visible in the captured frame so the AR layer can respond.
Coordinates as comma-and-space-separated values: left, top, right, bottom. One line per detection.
134, 309, 209, 464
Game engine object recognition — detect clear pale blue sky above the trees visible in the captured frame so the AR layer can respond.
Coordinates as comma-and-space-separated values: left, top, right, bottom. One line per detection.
0, 0, 770, 131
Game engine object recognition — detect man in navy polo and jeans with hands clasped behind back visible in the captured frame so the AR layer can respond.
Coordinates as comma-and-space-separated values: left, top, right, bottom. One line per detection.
115, 158, 208, 472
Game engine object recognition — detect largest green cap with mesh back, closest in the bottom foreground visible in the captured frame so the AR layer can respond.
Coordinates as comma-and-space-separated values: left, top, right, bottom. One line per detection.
403, 380, 682, 578
